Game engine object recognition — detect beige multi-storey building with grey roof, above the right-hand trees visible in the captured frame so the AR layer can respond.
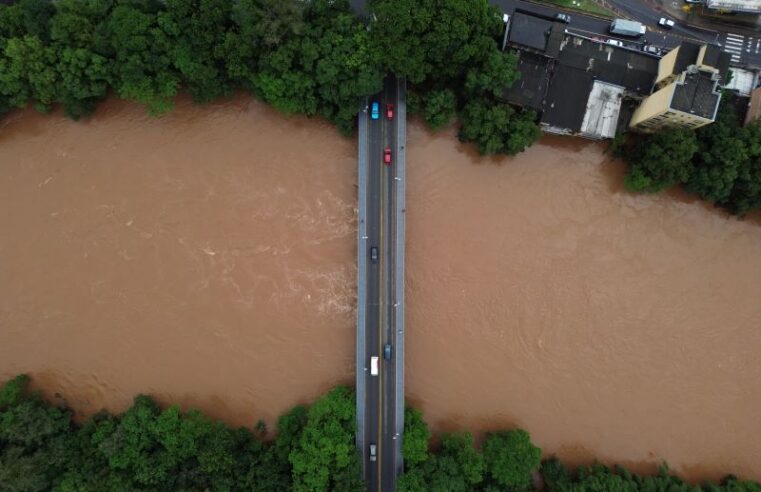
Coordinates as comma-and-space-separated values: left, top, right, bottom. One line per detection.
629, 42, 729, 132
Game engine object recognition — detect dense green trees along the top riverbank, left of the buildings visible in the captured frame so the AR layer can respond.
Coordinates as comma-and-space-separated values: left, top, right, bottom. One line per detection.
0, 0, 539, 153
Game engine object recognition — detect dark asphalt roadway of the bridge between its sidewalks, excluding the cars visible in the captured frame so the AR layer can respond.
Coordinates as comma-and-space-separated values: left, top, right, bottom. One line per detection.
362, 77, 398, 491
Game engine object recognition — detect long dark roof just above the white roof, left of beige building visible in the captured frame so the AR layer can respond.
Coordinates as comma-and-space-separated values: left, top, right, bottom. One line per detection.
558, 35, 659, 95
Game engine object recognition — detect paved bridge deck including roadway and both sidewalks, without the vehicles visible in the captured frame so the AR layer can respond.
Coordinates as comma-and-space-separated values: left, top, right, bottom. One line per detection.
357, 77, 404, 491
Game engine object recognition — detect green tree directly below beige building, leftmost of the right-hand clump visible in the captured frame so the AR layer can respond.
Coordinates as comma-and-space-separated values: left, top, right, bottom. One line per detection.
624, 130, 698, 193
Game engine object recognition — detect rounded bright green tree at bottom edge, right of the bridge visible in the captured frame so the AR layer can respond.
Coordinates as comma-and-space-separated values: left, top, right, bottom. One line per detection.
483, 429, 542, 490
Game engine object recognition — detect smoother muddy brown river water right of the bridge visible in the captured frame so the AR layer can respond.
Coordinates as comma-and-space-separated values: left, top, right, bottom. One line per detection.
407, 125, 761, 479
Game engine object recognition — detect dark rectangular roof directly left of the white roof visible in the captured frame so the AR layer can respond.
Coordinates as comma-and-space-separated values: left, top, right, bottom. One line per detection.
541, 65, 594, 133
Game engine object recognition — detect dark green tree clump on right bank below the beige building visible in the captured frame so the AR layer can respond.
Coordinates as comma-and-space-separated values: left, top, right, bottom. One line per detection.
614, 94, 761, 216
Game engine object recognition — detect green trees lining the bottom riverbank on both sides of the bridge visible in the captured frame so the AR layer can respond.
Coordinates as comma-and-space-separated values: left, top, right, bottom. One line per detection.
0, 376, 761, 492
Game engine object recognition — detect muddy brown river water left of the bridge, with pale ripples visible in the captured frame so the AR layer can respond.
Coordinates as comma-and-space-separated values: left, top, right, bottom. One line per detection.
0, 97, 356, 425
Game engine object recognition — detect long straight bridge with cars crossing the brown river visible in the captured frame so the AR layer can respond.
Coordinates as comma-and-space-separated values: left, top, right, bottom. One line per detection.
356, 77, 406, 491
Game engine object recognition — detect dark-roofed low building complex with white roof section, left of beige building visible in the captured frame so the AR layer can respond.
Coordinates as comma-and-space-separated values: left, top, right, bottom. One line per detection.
504, 9, 658, 139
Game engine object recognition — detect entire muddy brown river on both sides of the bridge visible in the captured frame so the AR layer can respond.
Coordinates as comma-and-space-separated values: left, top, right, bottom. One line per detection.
0, 97, 761, 479
